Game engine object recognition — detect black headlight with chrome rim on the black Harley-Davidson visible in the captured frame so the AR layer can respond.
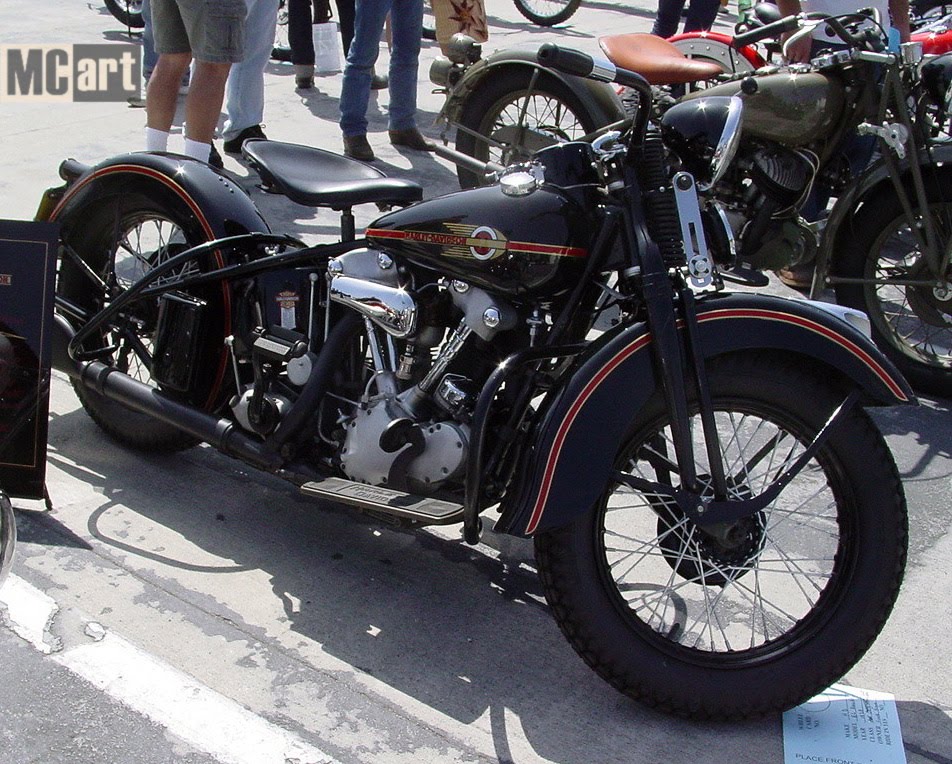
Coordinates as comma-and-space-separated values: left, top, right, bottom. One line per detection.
661, 96, 744, 189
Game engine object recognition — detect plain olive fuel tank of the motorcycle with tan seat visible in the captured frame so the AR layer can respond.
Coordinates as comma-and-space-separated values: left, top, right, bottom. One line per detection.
682, 72, 845, 147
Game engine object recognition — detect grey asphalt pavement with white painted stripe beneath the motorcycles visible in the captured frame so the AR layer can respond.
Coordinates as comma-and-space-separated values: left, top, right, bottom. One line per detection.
0, 0, 952, 764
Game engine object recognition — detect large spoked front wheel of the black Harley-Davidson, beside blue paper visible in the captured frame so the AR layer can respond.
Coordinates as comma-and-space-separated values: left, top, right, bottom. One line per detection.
536, 354, 907, 720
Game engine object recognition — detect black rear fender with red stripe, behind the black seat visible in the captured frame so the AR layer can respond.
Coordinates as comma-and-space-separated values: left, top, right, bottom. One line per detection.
49, 152, 270, 239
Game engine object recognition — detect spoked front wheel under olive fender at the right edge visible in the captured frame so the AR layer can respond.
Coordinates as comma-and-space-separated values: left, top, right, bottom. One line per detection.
834, 175, 952, 397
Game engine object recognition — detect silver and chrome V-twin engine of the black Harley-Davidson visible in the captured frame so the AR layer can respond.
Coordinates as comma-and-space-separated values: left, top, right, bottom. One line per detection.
211, 249, 518, 494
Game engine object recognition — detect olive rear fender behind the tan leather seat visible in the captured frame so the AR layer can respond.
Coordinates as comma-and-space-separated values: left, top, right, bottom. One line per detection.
443, 48, 625, 125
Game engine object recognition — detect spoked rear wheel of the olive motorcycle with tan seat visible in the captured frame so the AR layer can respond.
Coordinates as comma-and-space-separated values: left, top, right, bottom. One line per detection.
456, 66, 600, 188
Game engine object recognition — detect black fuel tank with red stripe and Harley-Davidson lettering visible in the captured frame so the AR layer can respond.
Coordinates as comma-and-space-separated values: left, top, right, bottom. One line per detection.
365, 183, 598, 297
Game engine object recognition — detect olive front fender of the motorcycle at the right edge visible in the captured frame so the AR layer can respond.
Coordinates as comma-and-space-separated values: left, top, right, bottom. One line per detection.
817, 144, 952, 275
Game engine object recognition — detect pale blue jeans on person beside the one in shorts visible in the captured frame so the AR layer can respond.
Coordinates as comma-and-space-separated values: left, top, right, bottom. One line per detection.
222, 0, 278, 141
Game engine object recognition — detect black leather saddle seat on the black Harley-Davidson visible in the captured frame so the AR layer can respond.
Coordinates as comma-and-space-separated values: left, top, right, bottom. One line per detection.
241, 141, 423, 210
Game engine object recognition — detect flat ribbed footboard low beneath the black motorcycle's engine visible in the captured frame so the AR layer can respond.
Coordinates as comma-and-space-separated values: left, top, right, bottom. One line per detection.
301, 478, 463, 525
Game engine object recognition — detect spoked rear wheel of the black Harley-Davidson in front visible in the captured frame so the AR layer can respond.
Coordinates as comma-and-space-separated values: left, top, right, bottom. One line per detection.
57, 193, 225, 452
